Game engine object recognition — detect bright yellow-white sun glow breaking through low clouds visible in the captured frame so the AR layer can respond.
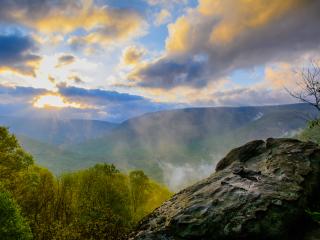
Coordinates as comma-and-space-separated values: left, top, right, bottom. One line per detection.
33, 94, 87, 108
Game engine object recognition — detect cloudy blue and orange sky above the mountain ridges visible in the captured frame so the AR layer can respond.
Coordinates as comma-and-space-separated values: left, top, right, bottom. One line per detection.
0, 0, 320, 122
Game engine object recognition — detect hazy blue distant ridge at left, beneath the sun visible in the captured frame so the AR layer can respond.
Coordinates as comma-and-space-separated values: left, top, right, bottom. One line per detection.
0, 116, 117, 145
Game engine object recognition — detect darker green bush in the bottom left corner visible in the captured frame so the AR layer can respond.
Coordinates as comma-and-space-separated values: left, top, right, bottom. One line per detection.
0, 189, 32, 240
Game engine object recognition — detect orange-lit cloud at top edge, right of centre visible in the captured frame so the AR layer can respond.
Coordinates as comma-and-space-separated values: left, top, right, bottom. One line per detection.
206, 0, 303, 44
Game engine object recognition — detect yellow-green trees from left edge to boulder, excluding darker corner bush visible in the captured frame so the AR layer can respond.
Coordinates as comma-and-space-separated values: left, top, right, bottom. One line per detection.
0, 127, 170, 240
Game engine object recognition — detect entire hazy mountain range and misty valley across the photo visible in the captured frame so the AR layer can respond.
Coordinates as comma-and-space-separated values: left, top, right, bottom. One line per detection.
0, 104, 317, 190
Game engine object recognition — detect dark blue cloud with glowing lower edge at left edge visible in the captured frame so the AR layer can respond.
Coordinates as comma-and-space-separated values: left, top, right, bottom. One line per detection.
0, 34, 41, 77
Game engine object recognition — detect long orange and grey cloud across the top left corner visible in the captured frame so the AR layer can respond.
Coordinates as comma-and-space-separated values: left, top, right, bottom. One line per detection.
0, 0, 147, 44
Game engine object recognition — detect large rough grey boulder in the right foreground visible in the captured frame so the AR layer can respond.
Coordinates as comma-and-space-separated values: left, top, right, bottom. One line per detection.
130, 139, 320, 240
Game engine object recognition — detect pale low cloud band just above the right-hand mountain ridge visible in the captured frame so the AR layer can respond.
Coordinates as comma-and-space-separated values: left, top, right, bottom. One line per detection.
132, 71, 296, 107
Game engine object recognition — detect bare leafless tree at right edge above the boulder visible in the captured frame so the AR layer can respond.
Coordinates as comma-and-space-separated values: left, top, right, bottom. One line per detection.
286, 60, 320, 112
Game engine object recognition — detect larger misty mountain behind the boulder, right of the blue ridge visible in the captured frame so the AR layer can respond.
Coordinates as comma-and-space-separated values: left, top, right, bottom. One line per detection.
68, 104, 317, 188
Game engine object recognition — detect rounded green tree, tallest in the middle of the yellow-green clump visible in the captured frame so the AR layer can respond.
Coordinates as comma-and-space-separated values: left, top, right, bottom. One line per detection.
77, 164, 132, 239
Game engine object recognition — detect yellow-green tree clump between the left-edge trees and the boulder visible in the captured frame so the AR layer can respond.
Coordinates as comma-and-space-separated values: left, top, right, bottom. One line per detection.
26, 164, 170, 239
